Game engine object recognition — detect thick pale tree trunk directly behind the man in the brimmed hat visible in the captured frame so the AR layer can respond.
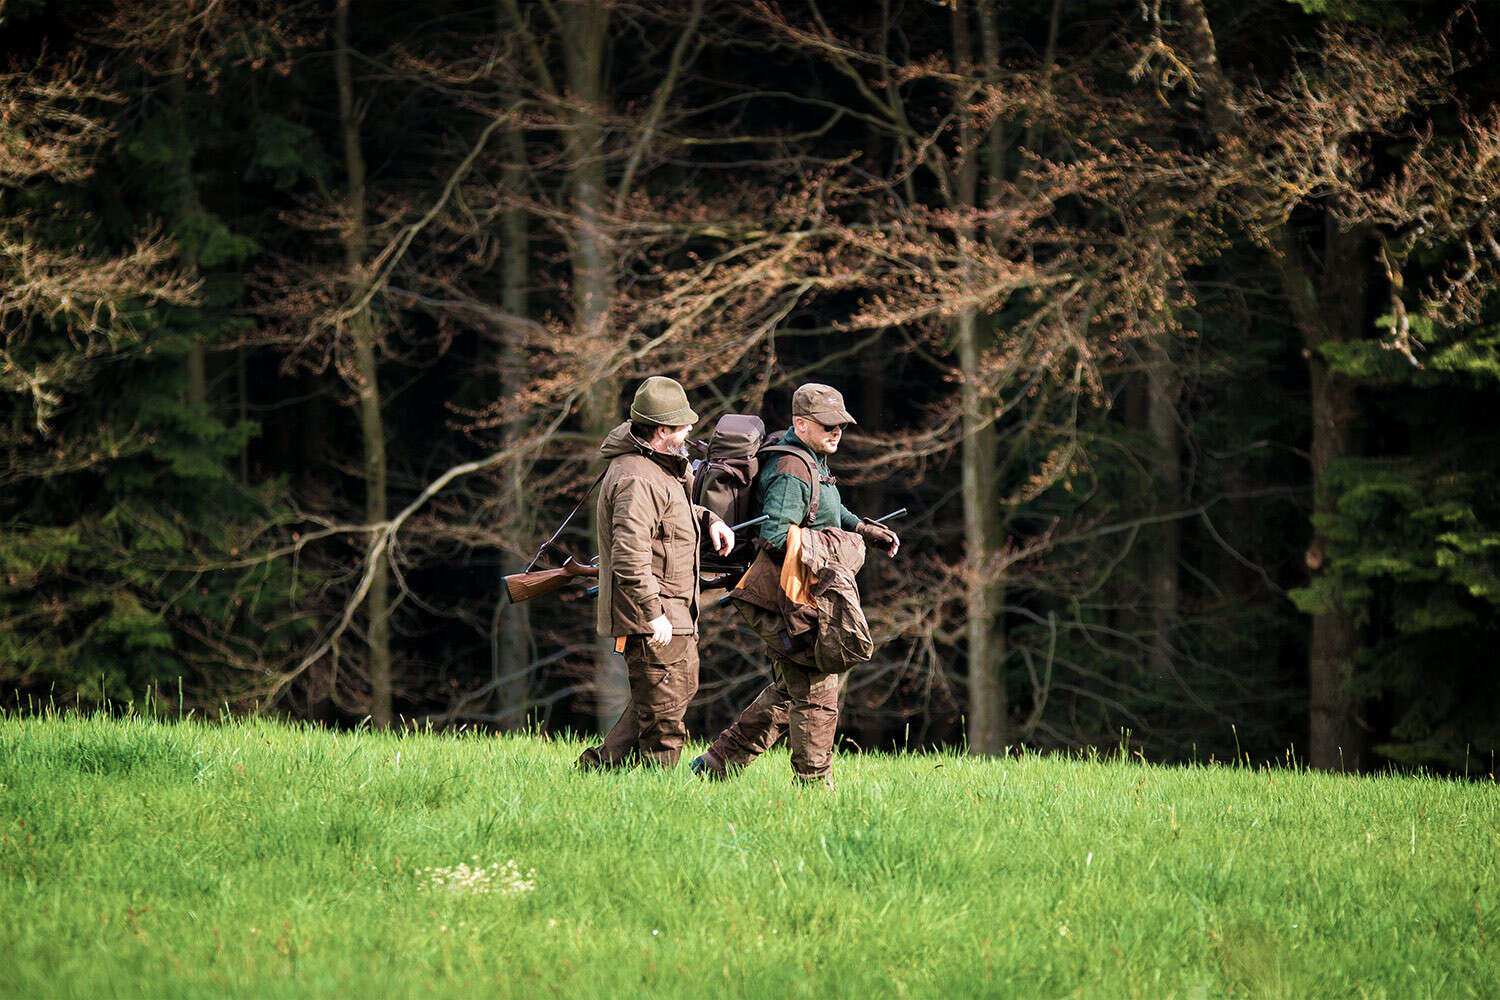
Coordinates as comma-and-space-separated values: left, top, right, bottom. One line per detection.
566, 0, 630, 729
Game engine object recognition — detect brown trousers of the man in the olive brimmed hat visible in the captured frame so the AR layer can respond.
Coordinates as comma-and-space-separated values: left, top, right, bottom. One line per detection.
578, 636, 698, 771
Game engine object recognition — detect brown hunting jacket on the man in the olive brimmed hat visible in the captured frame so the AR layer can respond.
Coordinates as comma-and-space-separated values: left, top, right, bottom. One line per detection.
596, 421, 719, 636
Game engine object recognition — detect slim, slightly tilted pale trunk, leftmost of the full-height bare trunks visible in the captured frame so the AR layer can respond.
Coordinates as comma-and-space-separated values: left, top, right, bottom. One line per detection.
333, 0, 392, 729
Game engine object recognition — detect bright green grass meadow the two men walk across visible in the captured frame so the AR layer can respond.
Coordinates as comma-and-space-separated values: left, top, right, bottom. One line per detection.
0, 707, 1500, 1000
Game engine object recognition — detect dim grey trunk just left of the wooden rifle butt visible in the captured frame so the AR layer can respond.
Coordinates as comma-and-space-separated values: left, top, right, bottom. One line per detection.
494, 122, 536, 730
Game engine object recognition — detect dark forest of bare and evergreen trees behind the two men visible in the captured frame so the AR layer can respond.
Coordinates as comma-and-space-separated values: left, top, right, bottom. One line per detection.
0, 0, 1500, 769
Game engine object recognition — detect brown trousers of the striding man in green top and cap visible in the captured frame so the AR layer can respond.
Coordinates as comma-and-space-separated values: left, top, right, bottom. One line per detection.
707, 658, 845, 781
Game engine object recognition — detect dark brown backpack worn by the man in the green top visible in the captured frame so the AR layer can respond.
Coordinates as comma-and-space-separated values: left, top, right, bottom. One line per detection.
693, 414, 821, 562
